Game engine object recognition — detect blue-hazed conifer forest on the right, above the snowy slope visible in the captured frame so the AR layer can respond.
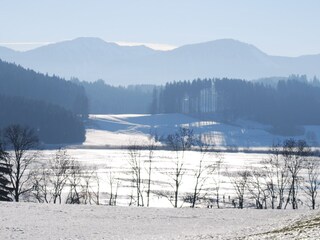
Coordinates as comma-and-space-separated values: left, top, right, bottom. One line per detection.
151, 76, 320, 134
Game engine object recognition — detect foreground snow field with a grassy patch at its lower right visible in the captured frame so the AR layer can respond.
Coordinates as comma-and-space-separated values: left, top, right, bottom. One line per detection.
0, 203, 320, 240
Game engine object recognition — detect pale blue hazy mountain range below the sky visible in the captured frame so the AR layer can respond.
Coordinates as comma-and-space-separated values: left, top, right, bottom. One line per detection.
0, 38, 320, 85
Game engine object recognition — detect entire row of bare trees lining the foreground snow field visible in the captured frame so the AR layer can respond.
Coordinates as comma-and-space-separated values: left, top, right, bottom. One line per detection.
0, 125, 320, 209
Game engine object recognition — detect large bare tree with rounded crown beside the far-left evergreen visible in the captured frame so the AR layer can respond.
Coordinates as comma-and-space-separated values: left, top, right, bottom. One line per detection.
3, 125, 38, 202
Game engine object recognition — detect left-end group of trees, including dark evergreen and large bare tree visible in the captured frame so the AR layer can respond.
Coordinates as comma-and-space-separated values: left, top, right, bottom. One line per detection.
0, 125, 99, 204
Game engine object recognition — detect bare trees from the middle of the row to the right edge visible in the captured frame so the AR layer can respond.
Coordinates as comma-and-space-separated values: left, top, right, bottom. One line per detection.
124, 131, 320, 209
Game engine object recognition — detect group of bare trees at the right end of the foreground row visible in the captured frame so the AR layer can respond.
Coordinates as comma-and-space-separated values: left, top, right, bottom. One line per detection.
230, 139, 320, 209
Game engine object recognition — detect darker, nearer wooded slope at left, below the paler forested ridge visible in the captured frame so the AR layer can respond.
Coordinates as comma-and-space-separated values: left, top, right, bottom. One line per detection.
0, 96, 85, 143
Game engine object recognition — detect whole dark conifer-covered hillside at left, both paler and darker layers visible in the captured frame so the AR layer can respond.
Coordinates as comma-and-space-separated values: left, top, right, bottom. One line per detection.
0, 60, 88, 143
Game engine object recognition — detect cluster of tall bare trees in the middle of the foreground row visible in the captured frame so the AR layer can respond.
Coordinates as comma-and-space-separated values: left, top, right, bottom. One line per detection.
128, 128, 223, 208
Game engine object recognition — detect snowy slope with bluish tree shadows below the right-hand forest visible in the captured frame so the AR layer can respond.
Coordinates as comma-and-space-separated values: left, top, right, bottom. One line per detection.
84, 114, 320, 148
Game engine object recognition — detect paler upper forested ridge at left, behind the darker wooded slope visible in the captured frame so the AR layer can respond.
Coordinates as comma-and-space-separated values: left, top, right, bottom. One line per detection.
0, 60, 88, 116
